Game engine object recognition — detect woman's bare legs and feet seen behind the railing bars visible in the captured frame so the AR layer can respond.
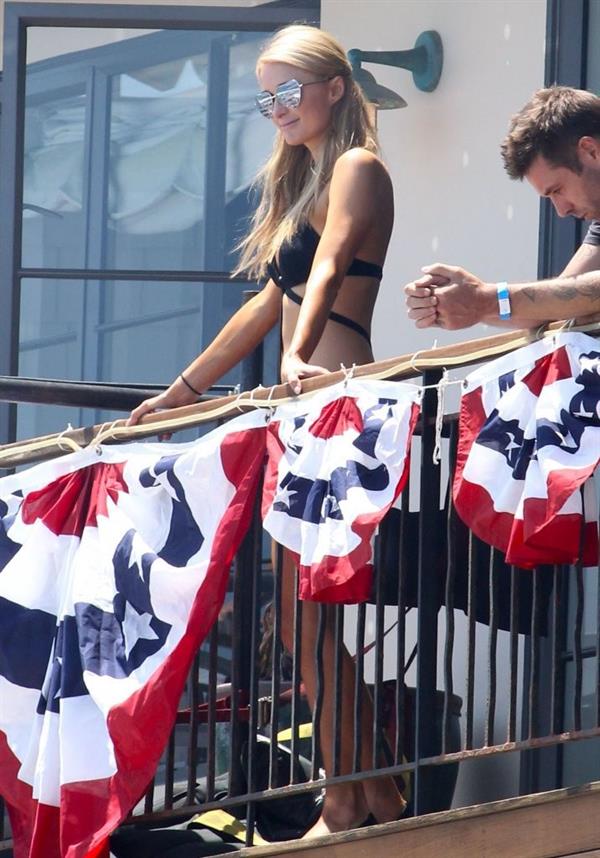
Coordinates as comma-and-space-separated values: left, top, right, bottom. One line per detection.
281, 551, 405, 837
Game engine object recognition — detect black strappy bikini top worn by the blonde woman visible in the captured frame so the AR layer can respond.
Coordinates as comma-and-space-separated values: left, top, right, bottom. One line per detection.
267, 221, 383, 344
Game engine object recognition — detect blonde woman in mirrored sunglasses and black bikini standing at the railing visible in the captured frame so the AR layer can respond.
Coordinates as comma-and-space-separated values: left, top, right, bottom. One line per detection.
130, 25, 404, 837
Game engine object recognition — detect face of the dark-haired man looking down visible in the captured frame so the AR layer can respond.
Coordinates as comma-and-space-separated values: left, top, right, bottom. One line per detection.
525, 137, 600, 220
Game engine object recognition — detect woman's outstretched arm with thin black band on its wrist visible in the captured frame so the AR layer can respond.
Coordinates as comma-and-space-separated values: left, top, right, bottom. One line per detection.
127, 280, 281, 426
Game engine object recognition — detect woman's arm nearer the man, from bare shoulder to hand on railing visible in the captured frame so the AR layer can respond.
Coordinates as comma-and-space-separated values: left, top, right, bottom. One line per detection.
281, 149, 393, 392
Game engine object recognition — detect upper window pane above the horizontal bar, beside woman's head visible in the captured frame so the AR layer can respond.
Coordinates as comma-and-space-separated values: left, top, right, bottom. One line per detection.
23, 27, 273, 271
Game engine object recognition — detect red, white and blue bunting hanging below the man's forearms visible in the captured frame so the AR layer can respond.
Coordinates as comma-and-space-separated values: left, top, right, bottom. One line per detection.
454, 333, 600, 567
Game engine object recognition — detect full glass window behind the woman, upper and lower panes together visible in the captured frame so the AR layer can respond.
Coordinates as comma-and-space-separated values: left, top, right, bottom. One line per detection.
18, 21, 286, 438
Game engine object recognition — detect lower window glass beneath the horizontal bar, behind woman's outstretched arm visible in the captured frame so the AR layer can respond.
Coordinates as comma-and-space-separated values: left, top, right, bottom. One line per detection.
17, 278, 279, 440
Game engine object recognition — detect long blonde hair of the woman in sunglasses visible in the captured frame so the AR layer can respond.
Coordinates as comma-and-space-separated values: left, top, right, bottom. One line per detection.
235, 24, 379, 279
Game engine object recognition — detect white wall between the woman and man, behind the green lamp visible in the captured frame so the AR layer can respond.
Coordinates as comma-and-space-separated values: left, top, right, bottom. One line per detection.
321, 0, 546, 358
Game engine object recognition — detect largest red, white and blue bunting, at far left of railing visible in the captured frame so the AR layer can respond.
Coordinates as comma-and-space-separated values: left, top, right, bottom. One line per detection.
0, 413, 265, 858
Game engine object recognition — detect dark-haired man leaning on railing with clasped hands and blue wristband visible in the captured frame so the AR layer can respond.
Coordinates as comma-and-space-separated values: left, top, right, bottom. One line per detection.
404, 86, 600, 330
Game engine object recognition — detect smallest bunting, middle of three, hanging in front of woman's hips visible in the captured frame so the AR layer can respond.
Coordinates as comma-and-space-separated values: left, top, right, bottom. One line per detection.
263, 379, 420, 602
